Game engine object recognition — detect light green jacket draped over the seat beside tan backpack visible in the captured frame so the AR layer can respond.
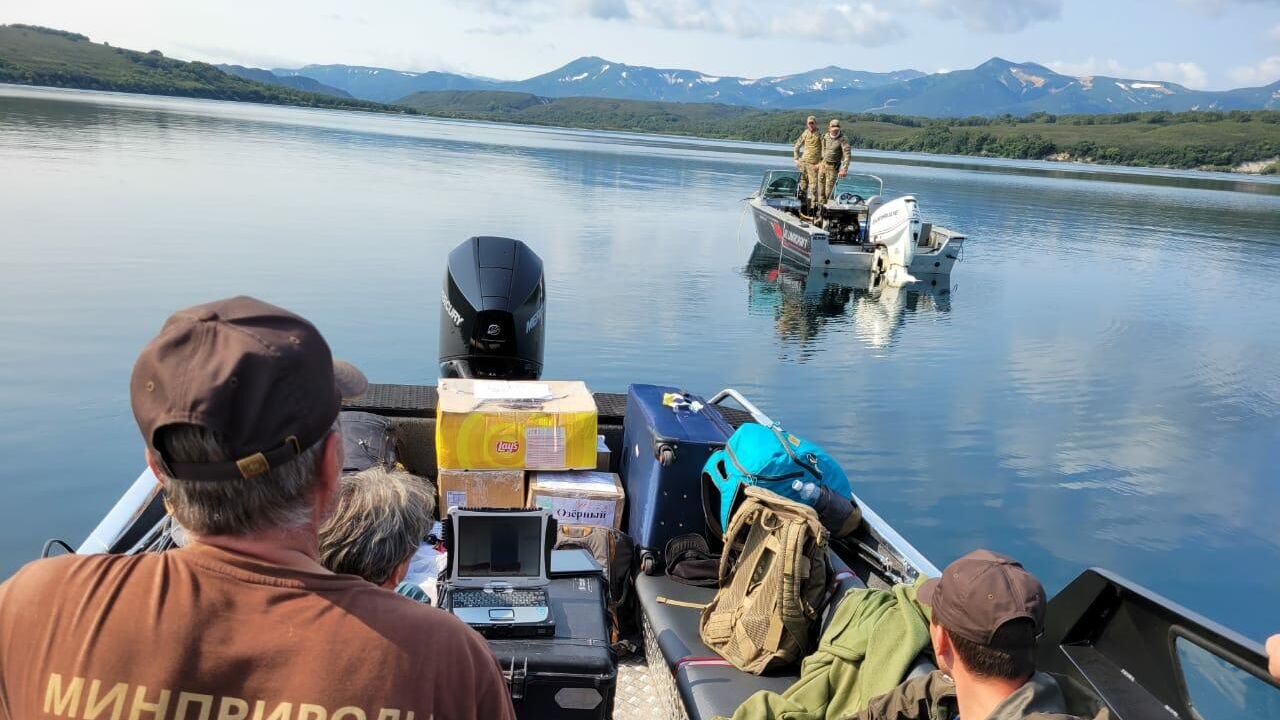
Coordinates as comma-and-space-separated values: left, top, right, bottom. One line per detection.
733, 585, 929, 720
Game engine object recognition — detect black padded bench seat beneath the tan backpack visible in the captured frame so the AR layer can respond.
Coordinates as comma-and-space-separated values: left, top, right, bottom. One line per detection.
635, 553, 865, 720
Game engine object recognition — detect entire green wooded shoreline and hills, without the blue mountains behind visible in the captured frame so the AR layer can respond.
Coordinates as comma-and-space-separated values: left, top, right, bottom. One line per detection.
0, 24, 1280, 174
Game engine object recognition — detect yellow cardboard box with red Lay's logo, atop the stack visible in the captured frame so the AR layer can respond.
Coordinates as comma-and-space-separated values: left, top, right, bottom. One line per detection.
435, 379, 598, 470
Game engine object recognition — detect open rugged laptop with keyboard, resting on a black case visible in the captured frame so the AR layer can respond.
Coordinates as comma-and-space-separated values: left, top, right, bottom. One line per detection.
445, 507, 556, 637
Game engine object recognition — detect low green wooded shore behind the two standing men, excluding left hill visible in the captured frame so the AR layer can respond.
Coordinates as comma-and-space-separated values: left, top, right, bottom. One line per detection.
399, 91, 1280, 169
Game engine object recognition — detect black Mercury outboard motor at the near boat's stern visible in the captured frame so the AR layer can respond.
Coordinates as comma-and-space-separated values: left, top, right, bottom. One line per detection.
440, 237, 547, 380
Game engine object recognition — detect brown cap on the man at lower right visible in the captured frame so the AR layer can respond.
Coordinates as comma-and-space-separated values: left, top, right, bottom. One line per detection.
916, 550, 1044, 646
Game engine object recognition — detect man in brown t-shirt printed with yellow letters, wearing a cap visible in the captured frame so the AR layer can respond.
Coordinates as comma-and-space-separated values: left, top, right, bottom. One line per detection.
0, 297, 515, 720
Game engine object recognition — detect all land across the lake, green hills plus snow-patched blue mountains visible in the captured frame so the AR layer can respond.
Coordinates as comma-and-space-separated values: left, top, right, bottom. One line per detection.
0, 24, 1280, 174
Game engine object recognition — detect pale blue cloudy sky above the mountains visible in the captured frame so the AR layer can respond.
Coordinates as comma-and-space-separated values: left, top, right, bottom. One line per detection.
0, 0, 1280, 88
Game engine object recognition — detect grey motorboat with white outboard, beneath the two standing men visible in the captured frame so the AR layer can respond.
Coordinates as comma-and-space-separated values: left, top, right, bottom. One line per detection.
748, 170, 965, 279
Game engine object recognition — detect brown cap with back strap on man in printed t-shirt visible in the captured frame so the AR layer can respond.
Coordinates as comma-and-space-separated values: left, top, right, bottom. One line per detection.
129, 296, 369, 480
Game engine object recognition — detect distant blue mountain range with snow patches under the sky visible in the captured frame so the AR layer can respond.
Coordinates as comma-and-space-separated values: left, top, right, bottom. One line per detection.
271, 56, 1280, 118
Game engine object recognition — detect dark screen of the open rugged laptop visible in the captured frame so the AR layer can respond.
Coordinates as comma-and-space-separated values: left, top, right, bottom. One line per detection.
454, 514, 543, 578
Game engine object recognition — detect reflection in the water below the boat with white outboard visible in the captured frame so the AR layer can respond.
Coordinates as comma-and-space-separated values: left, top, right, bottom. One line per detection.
745, 245, 951, 347
